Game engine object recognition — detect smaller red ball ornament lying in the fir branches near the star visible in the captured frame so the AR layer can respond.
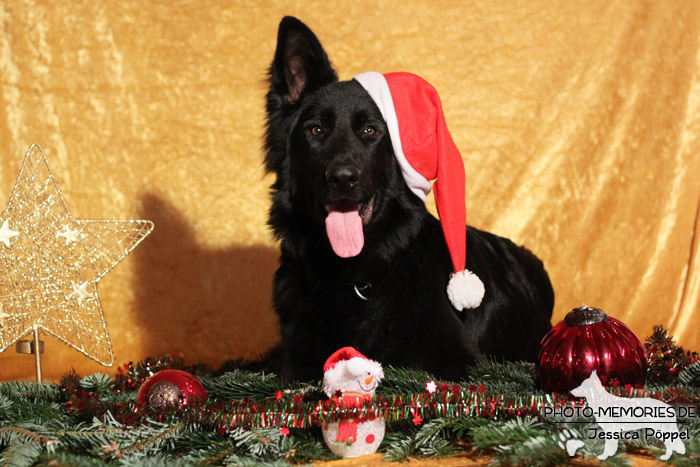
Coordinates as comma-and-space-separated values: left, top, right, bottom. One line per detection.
136, 370, 207, 409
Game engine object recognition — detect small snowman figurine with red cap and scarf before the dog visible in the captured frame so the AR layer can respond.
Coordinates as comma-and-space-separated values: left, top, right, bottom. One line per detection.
323, 347, 385, 457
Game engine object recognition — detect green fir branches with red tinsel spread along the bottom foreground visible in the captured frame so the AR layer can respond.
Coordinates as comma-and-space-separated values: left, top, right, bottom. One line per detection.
0, 327, 700, 466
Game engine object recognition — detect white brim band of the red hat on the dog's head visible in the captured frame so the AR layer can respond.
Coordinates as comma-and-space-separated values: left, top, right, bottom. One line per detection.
354, 71, 431, 203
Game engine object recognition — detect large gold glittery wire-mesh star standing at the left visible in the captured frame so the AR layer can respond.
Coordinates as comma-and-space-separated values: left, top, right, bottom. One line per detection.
0, 144, 153, 366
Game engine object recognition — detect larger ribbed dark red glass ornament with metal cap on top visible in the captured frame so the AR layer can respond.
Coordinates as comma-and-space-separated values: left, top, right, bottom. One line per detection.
536, 306, 646, 393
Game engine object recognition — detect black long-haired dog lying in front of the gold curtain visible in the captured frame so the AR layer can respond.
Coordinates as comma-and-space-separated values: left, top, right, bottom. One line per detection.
265, 17, 554, 380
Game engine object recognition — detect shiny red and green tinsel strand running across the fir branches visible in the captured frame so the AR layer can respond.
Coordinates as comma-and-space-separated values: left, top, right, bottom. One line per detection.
62, 326, 700, 431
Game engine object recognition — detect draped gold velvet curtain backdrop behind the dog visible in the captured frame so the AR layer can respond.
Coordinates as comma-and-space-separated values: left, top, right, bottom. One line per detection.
0, 0, 700, 380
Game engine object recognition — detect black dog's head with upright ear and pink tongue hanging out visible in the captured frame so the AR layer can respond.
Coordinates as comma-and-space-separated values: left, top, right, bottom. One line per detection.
265, 17, 422, 258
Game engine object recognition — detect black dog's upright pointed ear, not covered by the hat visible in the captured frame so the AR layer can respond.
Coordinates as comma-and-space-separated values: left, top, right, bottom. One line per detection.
270, 16, 338, 104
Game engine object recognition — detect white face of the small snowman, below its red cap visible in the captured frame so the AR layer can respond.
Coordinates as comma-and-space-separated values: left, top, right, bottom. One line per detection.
323, 358, 384, 397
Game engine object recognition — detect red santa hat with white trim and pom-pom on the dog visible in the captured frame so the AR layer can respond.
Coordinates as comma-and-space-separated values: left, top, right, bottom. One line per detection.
355, 71, 484, 310
